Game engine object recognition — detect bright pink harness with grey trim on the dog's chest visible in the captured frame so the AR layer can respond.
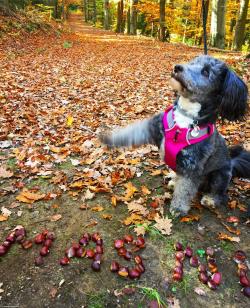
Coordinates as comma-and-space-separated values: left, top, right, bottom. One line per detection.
162, 106, 215, 170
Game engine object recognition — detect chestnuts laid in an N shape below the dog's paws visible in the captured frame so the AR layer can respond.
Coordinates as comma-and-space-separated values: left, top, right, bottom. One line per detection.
172, 243, 222, 290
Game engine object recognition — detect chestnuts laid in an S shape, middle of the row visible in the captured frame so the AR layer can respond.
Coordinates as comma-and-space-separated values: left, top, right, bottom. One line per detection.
110, 234, 145, 279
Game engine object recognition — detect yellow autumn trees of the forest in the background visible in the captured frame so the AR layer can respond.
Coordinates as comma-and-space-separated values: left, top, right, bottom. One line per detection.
0, 0, 250, 52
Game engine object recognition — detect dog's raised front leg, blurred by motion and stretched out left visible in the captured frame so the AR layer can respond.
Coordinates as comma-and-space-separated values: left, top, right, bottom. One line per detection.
100, 114, 162, 148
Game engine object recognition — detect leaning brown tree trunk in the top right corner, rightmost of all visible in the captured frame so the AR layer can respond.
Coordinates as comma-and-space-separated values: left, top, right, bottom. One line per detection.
233, 0, 249, 50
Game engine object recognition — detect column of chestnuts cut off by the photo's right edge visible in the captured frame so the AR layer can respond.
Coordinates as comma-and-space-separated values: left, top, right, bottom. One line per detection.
233, 250, 250, 297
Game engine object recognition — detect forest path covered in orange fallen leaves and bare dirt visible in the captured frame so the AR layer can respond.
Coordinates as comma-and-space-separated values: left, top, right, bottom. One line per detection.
0, 15, 250, 308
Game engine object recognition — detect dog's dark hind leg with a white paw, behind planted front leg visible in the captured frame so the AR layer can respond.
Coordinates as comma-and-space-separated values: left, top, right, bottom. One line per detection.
201, 165, 232, 207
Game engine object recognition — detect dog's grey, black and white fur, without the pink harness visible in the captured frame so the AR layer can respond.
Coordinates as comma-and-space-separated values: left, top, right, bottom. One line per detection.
101, 56, 250, 215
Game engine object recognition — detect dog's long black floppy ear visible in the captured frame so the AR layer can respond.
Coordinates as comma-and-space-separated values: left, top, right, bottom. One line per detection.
220, 69, 248, 121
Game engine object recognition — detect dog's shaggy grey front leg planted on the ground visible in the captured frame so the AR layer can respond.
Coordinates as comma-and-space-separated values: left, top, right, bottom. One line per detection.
170, 175, 200, 216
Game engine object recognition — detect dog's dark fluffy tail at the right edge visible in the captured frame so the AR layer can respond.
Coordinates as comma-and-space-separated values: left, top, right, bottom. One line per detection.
229, 145, 250, 179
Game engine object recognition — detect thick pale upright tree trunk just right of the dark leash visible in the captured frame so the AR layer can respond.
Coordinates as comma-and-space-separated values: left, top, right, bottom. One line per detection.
210, 0, 227, 49
